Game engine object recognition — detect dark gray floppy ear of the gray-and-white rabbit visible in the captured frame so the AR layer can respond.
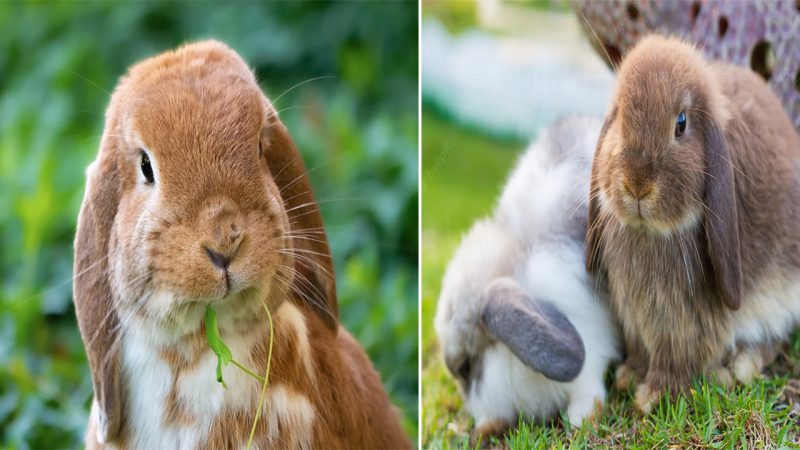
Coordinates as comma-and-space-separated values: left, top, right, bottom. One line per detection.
481, 278, 586, 382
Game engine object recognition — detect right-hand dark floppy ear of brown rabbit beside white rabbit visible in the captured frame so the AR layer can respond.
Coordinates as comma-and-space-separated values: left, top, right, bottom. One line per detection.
704, 120, 743, 310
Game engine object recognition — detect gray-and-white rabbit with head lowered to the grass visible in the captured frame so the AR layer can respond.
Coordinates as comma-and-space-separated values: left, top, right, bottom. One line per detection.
435, 117, 621, 435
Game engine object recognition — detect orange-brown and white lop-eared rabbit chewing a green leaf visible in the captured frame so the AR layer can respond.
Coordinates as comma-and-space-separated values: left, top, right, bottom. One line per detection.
74, 41, 410, 449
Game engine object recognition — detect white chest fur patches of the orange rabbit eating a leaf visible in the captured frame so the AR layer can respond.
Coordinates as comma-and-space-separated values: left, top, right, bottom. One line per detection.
121, 303, 316, 449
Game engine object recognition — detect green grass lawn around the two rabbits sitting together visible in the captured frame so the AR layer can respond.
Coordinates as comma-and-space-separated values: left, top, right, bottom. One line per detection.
421, 107, 800, 449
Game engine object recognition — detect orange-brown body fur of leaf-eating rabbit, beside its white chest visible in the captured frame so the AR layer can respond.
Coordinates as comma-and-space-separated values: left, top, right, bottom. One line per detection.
195, 300, 410, 449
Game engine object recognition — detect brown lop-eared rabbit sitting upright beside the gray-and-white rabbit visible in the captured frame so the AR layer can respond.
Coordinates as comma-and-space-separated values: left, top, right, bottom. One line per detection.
586, 36, 800, 411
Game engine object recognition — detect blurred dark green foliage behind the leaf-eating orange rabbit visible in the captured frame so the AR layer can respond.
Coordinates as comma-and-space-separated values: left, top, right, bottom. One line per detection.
0, 1, 418, 449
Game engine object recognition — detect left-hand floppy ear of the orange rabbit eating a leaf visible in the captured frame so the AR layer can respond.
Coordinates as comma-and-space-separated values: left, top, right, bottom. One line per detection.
73, 133, 122, 443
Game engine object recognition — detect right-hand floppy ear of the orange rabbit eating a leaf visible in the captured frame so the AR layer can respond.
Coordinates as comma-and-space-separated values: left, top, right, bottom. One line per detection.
262, 112, 339, 332
